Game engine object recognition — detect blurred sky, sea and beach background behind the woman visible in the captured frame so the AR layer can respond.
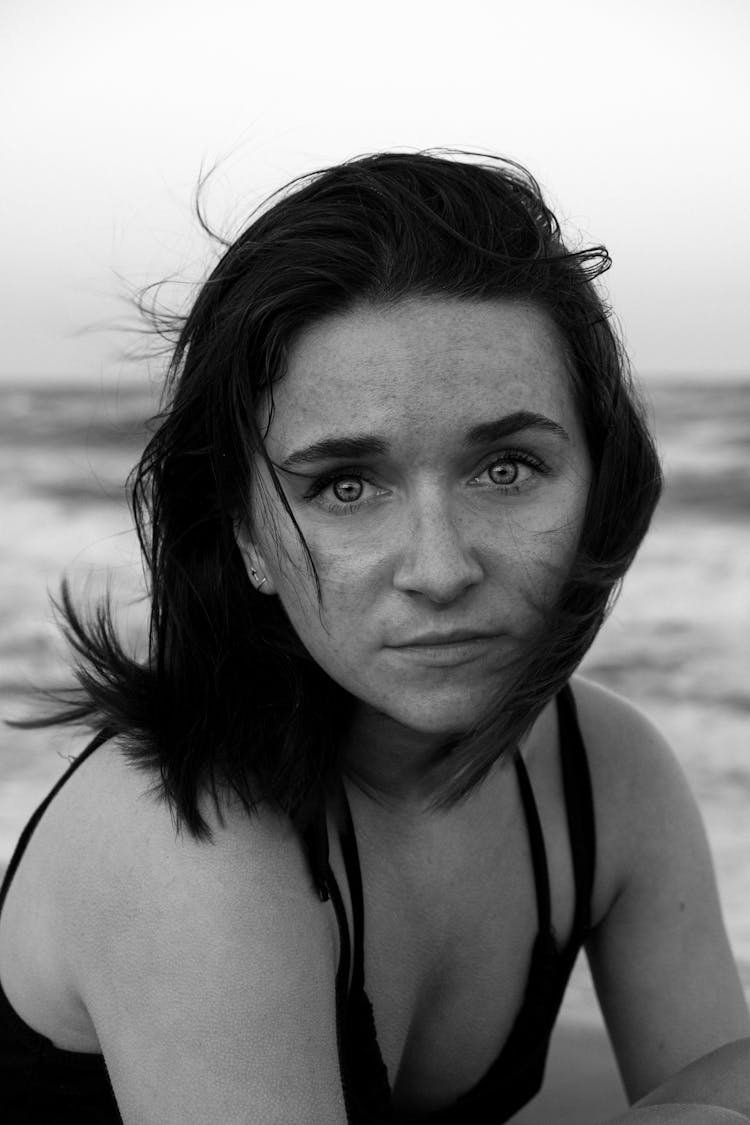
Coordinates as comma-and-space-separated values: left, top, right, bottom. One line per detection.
0, 0, 750, 1125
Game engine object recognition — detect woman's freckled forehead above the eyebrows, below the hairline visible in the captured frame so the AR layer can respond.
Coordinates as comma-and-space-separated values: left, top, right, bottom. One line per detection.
268, 297, 576, 456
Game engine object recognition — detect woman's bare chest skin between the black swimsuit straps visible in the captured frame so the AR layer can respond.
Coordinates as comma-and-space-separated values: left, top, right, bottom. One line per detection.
323, 765, 575, 1113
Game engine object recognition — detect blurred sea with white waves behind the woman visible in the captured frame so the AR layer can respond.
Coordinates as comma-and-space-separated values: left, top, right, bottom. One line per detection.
0, 374, 750, 1022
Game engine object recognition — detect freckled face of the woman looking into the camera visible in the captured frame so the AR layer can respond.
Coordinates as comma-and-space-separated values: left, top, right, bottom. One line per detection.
242, 297, 590, 736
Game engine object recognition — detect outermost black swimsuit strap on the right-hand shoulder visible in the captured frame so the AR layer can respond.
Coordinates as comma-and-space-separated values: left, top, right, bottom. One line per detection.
557, 684, 596, 939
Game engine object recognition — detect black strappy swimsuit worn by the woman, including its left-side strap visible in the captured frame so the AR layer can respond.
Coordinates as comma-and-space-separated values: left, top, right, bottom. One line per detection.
0, 687, 596, 1125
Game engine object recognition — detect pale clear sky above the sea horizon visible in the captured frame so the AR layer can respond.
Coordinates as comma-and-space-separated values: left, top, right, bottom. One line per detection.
0, 0, 750, 383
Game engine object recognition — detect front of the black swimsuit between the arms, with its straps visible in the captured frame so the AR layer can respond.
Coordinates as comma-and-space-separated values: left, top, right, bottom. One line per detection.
328, 686, 596, 1125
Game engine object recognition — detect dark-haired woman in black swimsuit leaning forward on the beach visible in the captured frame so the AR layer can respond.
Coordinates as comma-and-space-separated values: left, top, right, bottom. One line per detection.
0, 153, 750, 1125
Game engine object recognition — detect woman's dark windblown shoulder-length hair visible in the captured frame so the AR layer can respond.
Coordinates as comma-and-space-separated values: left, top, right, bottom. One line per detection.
19, 150, 661, 838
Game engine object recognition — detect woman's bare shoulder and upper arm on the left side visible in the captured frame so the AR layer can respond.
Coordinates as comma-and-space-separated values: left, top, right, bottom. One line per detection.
51, 744, 344, 1125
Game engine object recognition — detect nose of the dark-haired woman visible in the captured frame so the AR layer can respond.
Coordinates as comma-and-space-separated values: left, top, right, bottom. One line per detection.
394, 496, 484, 604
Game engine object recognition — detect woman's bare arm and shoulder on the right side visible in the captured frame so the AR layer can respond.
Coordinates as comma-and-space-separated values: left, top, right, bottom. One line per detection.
577, 684, 750, 1125
